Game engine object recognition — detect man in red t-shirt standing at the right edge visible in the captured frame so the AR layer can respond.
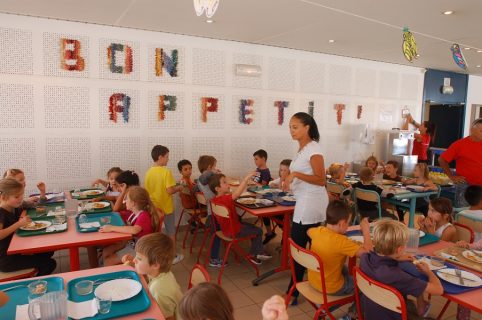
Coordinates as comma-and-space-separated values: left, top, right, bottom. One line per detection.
438, 118, 482, 208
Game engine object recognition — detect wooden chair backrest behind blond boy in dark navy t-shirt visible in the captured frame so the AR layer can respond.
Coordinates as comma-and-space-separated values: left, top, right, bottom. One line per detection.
354, 267, 407, 320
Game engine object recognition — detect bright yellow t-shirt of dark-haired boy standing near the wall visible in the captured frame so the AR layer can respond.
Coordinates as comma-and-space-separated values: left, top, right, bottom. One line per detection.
144, 167, 176, 214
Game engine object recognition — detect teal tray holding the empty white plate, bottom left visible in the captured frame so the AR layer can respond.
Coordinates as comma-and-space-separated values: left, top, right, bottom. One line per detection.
67, 270, 151, 320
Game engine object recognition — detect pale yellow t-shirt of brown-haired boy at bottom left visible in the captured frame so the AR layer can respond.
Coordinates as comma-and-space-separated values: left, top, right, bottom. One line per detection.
149, 271, 182, 318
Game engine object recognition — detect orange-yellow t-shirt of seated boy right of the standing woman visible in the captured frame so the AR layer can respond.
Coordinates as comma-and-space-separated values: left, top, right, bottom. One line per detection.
308, 227, 360, 293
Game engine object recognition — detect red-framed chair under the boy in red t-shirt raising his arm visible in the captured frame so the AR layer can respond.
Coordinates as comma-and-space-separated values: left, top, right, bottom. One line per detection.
206, 202, 259, 285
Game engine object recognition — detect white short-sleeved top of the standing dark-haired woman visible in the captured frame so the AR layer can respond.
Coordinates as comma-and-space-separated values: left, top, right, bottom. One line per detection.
290, 141, 328, 224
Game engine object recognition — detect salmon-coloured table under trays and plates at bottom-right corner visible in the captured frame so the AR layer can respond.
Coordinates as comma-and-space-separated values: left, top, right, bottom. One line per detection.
419, 241, 482, 319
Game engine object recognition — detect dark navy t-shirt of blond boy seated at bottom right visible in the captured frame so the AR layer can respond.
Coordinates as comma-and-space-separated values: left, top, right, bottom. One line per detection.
360, 251, 427, 320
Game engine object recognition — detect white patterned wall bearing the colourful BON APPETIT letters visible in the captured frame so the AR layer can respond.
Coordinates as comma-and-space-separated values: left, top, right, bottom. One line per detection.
0, 14, 423, 198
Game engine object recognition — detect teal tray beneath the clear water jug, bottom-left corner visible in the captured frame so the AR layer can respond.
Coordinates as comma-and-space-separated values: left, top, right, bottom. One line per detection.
0, 277, 64, 320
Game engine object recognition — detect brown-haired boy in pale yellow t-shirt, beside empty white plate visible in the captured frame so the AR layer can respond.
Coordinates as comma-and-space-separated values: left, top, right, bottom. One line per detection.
122, 232, 183, 320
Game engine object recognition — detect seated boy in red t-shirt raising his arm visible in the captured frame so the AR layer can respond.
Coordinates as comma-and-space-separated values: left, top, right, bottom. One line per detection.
209, 172, 271, 264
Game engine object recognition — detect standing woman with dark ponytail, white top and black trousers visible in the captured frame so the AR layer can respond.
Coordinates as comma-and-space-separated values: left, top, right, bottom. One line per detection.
286, 112, 328, 304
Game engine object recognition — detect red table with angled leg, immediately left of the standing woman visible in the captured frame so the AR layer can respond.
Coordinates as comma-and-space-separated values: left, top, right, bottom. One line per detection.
236, 202, 295, 286
